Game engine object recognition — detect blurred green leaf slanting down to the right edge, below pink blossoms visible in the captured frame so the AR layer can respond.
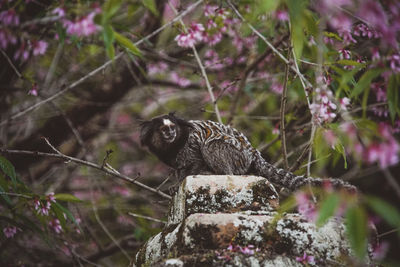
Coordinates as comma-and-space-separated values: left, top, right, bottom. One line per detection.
366, 196, 400, 235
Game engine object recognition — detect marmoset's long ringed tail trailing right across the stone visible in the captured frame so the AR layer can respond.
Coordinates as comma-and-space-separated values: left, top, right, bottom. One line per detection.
254, 151, 358, 193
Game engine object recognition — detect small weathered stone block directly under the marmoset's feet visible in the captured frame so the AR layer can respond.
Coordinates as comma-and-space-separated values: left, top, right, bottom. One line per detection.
168, 175, 279, 225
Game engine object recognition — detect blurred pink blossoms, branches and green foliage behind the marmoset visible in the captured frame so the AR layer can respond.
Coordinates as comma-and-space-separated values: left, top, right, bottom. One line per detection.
0, 0, 400, 266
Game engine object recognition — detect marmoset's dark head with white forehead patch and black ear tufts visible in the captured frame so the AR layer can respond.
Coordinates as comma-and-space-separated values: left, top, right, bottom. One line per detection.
140, 113, 190, 152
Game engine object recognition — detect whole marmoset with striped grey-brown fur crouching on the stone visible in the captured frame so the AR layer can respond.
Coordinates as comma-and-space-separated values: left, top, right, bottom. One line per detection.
140, 113, 357, 191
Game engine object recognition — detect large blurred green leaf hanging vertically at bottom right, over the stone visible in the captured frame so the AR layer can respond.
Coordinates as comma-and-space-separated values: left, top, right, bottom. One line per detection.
346, 206, 367, 260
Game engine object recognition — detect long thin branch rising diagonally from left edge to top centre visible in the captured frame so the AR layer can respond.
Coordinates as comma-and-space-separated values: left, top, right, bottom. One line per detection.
0, 0, 203, 126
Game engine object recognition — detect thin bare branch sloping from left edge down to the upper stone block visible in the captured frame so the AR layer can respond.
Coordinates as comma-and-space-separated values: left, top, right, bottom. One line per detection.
0, 146, 171, 199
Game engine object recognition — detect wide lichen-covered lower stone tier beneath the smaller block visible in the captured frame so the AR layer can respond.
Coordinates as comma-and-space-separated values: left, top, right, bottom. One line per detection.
136, 212, 350, 266
